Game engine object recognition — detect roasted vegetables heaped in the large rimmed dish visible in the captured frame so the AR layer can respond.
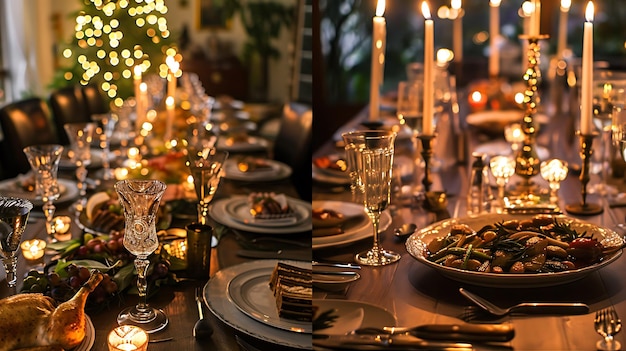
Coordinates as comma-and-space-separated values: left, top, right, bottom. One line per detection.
426, 215, 623, 273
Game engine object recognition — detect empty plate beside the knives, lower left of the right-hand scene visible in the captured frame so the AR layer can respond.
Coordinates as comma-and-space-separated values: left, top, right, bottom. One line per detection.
313, 299, 396, 335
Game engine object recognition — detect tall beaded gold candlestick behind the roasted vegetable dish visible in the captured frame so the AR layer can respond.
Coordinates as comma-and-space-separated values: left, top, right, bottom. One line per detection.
515, 35, 549, 193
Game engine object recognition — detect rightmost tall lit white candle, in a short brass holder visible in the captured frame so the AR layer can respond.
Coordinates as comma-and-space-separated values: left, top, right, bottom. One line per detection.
580, 1, 594, 135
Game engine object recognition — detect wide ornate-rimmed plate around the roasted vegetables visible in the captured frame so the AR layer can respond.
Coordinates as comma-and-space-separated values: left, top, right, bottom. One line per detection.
406, 213, 624, 288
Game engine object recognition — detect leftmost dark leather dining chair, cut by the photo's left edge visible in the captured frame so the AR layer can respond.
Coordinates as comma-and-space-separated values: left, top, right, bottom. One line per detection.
0, 97, 59, 178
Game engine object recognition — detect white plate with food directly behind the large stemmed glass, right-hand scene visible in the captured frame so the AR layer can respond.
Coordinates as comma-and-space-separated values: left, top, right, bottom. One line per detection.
311, 200, 391, 250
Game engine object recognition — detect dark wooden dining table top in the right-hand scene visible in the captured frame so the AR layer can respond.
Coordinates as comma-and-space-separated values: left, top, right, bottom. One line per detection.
313, 86, 626, 350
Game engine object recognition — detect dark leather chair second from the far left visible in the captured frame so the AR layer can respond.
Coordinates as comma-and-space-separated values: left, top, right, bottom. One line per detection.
49, 86, 91, 145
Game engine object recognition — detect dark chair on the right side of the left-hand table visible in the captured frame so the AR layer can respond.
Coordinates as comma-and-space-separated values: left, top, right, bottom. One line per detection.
273, 102, 313, 200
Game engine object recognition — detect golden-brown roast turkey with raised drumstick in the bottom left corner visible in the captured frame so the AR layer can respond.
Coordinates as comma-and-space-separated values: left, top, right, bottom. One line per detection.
0, 272, 102, 351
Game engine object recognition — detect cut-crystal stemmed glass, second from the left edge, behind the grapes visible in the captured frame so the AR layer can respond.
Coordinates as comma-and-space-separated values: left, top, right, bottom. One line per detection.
24, 144, 63, 242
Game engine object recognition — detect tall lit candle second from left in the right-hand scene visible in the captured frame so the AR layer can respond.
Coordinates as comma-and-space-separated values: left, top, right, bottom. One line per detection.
422, 1, 435, 135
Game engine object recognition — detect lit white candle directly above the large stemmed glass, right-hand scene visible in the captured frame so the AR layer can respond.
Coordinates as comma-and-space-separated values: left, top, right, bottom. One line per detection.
369, 0, 387, 121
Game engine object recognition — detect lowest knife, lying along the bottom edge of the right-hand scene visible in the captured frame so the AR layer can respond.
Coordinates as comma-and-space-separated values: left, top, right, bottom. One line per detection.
313, 334, 474, 351
